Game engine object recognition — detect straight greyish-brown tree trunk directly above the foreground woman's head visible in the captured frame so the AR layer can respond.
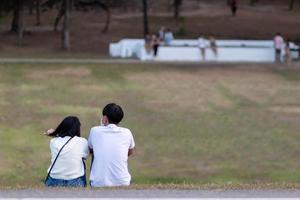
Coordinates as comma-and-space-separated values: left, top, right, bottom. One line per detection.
62, 0, 71, 50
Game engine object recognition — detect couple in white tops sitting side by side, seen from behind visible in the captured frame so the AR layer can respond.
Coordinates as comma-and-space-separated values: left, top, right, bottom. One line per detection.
45, 103, 135, 187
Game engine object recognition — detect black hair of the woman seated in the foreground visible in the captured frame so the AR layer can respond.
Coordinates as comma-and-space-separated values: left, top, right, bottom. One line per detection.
49, 116, 81, 137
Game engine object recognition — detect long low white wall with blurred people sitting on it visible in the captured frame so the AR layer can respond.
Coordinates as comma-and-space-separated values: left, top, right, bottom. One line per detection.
109, 39, 299, 62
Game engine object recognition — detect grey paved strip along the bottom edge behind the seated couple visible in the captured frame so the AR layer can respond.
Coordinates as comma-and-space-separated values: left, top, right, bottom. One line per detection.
0, 189, 300, 199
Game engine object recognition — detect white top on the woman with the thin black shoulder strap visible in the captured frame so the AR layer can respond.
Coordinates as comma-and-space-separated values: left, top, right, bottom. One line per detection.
48, 136, 89, 180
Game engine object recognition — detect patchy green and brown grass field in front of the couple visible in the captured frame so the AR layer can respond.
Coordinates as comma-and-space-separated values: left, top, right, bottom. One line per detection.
0, 64, 300, 187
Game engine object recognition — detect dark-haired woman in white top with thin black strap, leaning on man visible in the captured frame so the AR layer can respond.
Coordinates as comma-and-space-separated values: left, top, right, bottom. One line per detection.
45, 116, 89, 187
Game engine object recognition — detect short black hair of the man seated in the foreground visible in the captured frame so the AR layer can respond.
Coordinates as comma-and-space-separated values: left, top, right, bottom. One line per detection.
102, 103, 124, 124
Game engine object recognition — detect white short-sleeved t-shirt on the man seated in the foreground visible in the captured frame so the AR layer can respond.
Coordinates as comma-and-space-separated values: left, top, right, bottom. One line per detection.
88, 124, 135, 187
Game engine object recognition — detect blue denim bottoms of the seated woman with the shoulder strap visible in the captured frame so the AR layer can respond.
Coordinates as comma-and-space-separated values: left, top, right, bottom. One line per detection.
45, 175, 86, 187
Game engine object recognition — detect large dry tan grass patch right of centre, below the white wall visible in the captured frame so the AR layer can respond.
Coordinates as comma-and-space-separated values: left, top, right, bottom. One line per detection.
127, 68, 300, 111
